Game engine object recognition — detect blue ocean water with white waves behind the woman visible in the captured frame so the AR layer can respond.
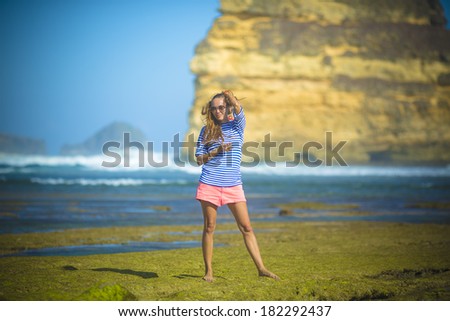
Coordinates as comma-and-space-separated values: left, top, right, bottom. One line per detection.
0, 155, 450, 233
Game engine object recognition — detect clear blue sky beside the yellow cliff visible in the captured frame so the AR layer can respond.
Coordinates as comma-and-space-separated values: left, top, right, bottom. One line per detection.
0, 0, 450, 154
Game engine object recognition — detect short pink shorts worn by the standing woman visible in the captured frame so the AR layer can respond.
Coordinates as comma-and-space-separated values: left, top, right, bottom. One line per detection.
195, 183, 247, 206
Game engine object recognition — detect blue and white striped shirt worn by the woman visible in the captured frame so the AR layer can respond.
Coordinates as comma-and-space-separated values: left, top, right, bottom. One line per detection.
195, 108, 245, 187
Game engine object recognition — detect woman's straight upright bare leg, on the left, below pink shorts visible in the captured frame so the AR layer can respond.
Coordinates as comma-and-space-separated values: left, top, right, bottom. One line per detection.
200, 201, 217, 282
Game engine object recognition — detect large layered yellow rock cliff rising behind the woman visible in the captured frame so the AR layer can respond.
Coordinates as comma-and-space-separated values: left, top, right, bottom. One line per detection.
186, 0, 450, 163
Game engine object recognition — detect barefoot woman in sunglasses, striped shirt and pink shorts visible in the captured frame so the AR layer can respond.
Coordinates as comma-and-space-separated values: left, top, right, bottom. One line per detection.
195, 90, 279, 282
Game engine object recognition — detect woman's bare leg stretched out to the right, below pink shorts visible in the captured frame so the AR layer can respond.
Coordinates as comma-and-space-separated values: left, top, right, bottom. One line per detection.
228, 202, 280, 280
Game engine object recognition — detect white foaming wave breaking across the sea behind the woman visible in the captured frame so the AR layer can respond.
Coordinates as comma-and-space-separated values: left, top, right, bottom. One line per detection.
0, 153, 450, 176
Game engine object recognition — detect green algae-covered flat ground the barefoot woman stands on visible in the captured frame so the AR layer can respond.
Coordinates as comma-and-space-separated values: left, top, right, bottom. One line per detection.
0, 222, 450, 301
